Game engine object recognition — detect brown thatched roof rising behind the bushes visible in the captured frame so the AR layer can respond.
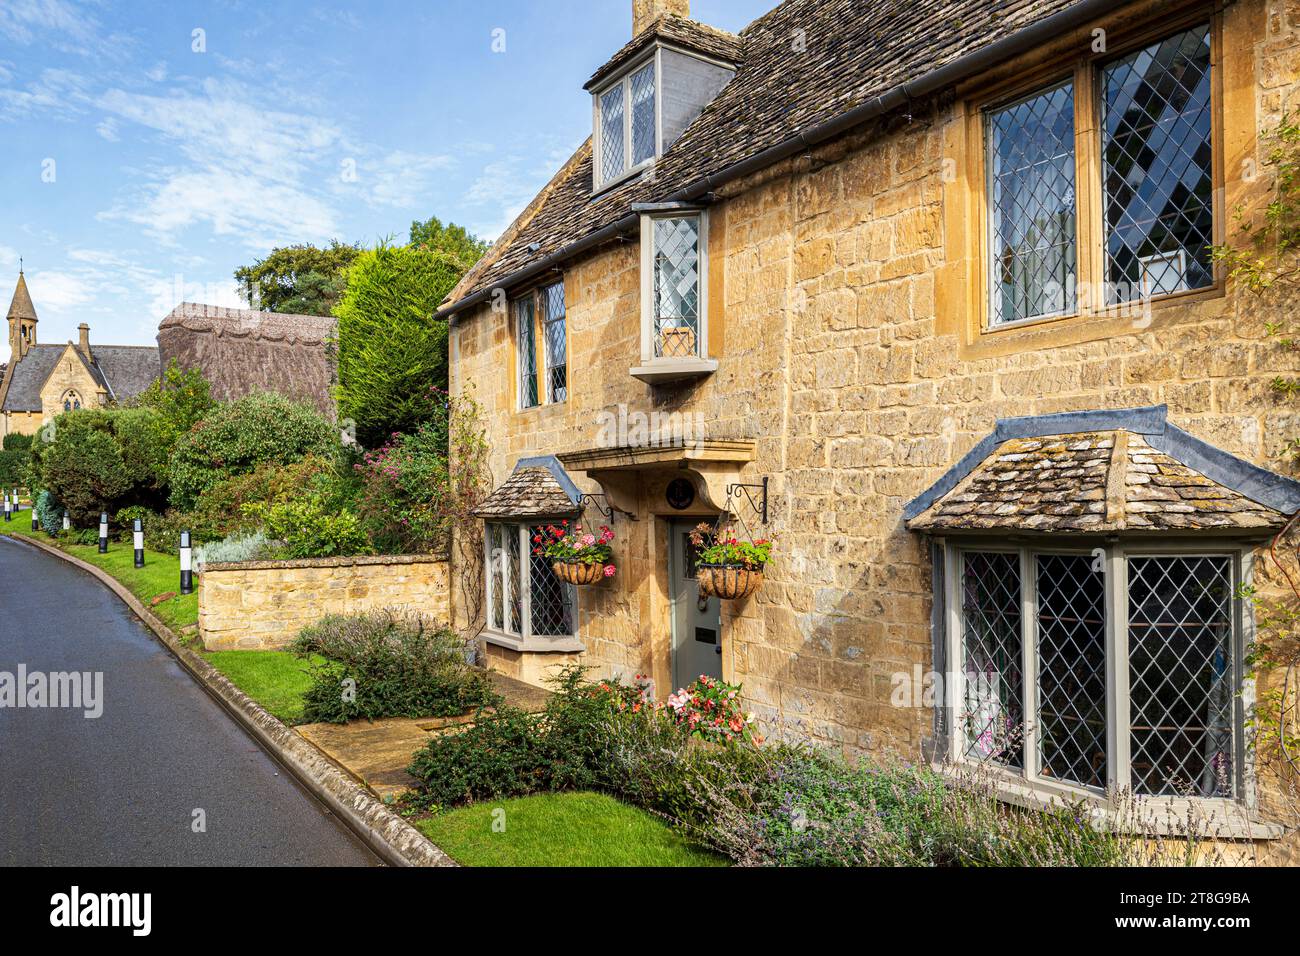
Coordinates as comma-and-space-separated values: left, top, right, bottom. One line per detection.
159, 302, 334, 418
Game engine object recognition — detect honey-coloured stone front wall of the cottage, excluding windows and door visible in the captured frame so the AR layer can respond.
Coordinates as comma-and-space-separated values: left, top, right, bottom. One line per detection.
452, 0, 1300, 758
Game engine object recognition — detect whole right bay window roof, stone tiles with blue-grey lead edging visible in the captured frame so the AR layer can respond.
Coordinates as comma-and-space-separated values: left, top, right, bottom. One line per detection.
904, 406, 1300, 535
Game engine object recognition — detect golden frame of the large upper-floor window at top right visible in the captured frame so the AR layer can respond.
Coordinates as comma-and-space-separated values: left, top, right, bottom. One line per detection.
939, 3, 1232, 358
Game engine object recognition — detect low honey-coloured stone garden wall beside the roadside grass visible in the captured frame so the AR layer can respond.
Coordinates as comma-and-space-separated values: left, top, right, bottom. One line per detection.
199, 555, 450, 650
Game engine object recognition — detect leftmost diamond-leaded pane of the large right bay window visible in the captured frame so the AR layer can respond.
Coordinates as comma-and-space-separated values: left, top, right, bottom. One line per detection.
958, 553, 1024, 767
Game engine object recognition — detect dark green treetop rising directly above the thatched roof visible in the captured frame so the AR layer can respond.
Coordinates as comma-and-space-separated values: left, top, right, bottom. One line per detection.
235, 239, 361, 315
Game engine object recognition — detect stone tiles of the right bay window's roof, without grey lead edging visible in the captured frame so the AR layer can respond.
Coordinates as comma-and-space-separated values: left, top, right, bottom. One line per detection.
907, 429, 1287, 533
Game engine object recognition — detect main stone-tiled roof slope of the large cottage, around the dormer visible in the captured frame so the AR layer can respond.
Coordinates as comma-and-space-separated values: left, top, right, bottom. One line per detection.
447, 0, 1073, 310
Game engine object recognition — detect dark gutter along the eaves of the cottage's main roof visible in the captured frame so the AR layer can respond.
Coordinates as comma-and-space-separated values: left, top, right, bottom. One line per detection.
433, 0, 1132, 320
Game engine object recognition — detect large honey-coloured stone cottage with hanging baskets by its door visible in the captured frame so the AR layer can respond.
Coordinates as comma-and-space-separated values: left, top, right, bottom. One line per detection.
439, 0, 1300, 836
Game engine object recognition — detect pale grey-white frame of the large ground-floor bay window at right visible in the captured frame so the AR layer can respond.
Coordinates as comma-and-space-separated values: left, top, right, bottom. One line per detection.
943, 537, 1256, 826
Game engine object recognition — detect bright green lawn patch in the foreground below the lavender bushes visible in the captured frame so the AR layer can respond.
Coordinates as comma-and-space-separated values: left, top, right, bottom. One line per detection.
412, 793, 728, 866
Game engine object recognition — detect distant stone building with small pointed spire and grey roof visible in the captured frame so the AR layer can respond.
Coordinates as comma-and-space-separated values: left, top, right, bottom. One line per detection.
0, 269, 159, 437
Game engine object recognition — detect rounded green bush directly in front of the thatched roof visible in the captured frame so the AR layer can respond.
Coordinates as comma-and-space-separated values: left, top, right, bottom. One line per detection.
169, 393, 338, 510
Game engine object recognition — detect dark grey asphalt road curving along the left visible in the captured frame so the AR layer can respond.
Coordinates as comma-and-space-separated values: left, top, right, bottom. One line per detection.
0, 537, 378, 866
